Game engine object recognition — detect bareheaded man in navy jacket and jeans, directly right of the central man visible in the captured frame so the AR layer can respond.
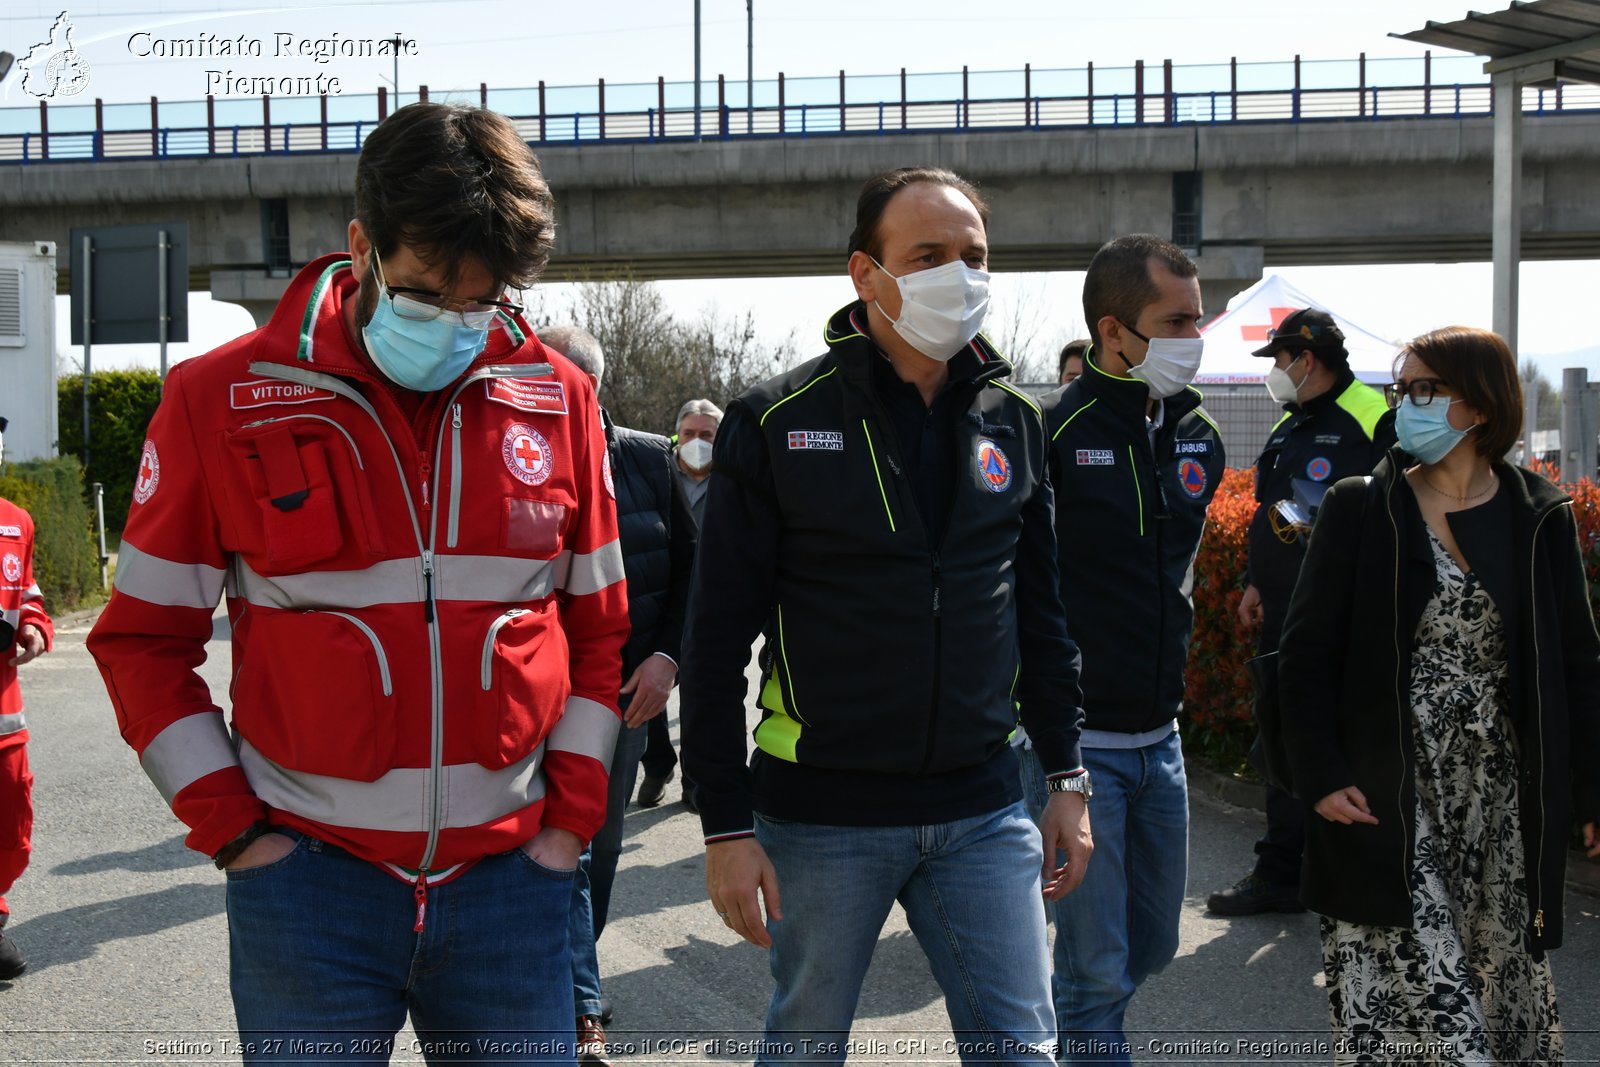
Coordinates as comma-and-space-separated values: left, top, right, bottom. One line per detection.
1022, 234, 1226, 1064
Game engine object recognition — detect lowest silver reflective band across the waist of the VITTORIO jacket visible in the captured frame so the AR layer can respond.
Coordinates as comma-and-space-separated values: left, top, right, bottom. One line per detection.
238, 739, 544, 833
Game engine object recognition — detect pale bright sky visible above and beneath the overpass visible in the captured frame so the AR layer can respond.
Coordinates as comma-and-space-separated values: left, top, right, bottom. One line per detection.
9, 0, 1600, 374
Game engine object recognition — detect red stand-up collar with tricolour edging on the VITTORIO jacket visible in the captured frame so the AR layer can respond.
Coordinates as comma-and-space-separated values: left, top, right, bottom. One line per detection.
251, 253, 549, 386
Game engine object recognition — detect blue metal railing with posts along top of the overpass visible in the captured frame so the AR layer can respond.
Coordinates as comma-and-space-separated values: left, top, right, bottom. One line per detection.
0, 59, 1600, 165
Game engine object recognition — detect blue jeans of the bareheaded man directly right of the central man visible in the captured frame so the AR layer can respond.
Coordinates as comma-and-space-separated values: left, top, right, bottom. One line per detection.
1021, 731, 1189, 1064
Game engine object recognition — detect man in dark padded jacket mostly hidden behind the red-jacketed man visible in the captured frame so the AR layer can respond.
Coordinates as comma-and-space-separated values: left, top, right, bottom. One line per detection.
539, 326, 696, 1067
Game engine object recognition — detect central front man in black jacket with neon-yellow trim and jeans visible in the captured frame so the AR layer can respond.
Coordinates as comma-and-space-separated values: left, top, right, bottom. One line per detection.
682, 168, 1090, 1064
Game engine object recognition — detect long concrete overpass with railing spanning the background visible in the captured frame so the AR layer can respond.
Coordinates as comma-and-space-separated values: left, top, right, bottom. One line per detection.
0, 61, 1600, 318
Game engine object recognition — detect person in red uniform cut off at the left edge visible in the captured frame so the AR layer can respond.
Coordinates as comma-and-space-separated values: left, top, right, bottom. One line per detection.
0, 418, 56, 981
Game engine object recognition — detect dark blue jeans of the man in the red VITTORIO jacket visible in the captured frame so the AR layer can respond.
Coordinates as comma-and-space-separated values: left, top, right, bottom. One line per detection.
227, 833, 576, 1064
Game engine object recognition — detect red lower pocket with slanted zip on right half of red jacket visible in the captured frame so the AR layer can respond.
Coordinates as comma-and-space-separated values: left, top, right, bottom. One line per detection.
474, 601, 570, 769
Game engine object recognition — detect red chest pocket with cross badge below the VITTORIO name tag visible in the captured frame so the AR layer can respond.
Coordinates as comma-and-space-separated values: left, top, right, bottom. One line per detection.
226, 414, 384, 574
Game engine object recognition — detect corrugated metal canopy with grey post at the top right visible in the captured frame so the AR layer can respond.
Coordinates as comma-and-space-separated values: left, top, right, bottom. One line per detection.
1390, 0, 1600, 367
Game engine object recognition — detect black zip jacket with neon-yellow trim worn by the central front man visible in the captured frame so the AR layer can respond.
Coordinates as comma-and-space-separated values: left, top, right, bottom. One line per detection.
682, 304, 1082, 838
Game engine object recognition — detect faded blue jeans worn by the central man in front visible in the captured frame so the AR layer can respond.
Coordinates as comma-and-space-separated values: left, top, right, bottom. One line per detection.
755, 803, 1054, 1064
